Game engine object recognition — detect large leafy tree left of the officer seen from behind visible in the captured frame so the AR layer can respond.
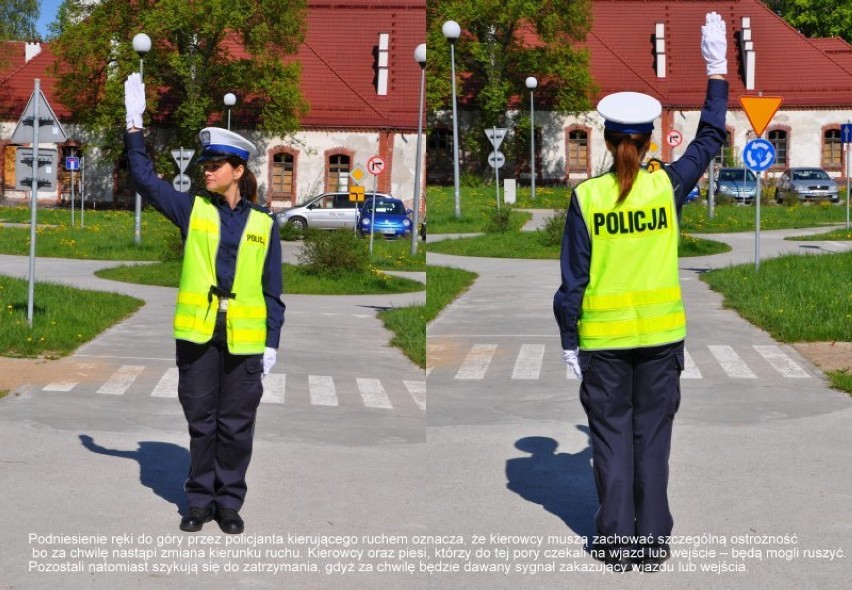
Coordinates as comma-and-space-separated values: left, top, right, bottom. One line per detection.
427, 0, 596, 176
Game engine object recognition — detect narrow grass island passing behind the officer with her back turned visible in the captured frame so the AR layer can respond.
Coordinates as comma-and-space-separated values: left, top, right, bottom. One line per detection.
429, 231, 731, 259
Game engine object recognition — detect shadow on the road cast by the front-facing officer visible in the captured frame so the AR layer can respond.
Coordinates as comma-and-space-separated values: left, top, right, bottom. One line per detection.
80, 434, 189, 514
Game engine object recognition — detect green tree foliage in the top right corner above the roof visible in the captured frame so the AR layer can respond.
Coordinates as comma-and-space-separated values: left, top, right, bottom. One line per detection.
766, 0, 852, 43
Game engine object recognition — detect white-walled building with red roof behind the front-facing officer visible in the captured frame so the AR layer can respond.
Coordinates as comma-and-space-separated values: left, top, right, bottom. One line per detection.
0, 0, 426, 208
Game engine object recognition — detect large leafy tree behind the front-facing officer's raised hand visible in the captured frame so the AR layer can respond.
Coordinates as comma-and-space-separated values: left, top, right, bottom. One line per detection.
51, 0, 306, 166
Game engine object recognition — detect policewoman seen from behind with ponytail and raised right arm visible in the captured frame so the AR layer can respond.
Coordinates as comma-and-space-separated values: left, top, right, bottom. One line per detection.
553, 13, 728, 571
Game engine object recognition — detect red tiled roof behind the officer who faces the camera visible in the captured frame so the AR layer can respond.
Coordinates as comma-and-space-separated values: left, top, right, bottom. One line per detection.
0, 0, 426, 129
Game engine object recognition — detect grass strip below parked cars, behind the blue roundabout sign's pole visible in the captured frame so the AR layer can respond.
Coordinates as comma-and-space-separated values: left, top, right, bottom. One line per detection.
681, 202, 846, 234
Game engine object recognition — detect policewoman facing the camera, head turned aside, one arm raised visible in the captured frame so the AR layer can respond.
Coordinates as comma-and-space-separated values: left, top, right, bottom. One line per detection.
125, 74, 284, 534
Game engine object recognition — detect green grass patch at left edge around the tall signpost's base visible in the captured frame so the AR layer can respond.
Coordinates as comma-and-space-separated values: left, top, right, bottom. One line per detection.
0, 276, 143, 358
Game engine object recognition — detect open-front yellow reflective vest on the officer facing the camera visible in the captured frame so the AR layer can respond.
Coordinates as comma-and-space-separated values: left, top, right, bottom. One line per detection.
174, 196, 272, 354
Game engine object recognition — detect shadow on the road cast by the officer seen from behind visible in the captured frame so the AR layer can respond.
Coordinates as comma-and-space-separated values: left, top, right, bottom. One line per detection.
506, 425, 598, 539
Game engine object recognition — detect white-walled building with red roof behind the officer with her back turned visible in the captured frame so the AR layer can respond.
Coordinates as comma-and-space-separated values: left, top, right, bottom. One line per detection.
429, 0, 852, 182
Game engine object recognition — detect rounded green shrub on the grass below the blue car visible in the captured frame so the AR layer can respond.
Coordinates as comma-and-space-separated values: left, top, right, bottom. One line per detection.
296, 229, 370, 277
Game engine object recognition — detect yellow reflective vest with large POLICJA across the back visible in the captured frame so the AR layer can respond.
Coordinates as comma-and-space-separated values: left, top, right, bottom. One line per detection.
574, 170, 686, 350
